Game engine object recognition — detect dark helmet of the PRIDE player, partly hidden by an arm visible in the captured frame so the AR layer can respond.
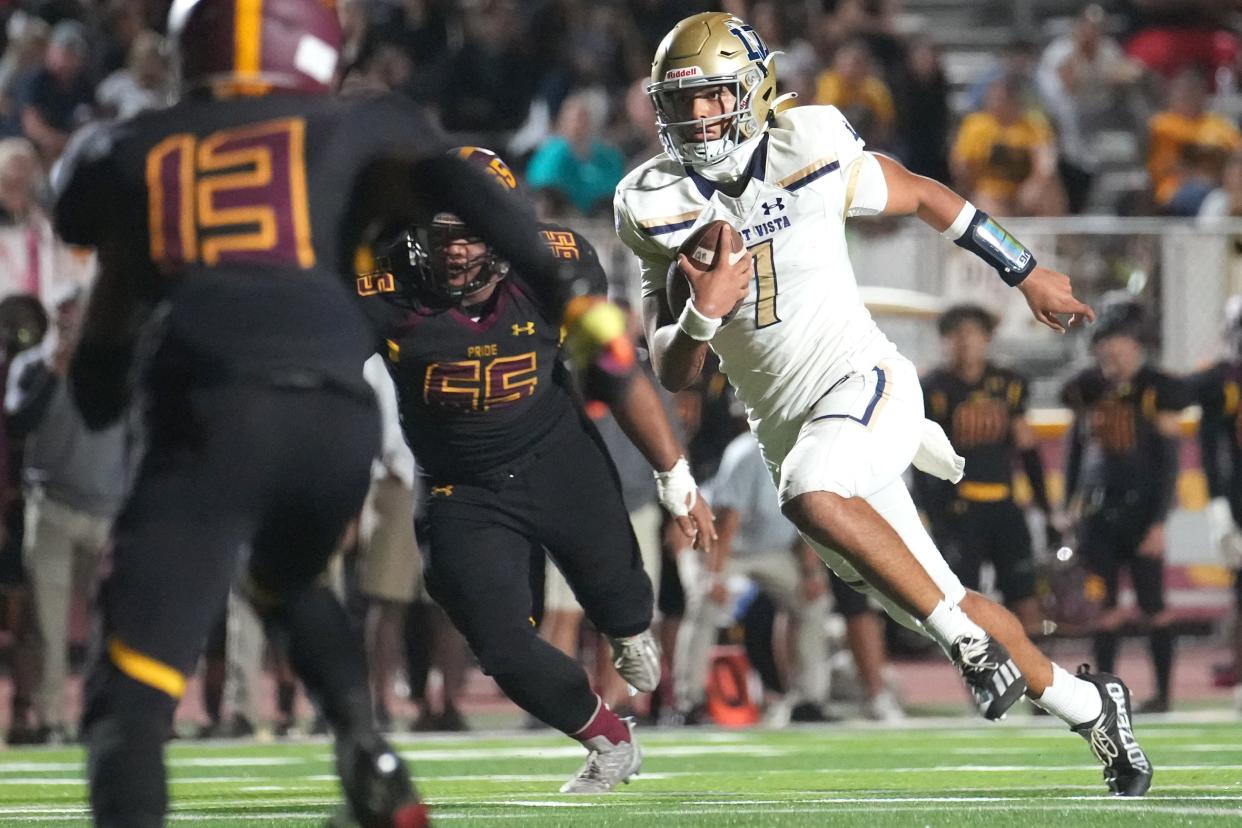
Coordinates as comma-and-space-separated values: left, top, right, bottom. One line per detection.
407, 146, 518, 303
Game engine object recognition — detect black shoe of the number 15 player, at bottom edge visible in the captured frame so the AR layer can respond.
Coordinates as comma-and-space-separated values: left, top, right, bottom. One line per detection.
337, 734, 427, 828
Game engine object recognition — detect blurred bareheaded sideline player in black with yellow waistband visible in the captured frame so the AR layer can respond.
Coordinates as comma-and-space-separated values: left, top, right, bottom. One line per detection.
914, 304, 1058, 636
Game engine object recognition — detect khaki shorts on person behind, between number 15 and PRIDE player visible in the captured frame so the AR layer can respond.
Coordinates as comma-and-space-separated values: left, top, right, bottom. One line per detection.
358, 477, 422, 603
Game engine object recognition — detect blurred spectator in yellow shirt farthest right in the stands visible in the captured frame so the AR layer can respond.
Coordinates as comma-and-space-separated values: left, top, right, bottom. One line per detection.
1148, 70, 1242, 216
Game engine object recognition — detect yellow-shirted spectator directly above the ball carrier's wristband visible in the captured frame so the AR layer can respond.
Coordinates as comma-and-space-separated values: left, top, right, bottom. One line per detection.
950, 74, 1066, 216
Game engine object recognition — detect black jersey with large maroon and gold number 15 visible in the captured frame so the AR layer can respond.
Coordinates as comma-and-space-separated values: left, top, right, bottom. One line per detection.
57, 94, 442, 386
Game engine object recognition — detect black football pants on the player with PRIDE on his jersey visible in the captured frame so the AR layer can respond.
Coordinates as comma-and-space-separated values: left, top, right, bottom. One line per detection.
425, 422, 653, 734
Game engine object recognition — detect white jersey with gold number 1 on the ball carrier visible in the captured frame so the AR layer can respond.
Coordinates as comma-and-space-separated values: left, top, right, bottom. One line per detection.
615, 106, 895, 441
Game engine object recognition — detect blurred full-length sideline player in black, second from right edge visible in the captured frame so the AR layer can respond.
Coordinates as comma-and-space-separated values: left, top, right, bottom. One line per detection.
1061, 294, 1187, 713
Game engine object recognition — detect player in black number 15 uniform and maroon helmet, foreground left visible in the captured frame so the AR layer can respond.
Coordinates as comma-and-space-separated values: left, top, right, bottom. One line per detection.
49, 0, 623, 828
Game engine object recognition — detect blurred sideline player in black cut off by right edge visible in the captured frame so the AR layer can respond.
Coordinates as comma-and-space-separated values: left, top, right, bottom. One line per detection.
1190, 294, 1242, 705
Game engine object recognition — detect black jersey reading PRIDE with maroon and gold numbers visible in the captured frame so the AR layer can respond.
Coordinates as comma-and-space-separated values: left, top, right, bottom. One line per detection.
358, 225, 606, 484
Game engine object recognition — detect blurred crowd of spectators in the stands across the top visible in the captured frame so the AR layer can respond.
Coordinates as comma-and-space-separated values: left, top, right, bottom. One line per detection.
0, 0, 1242, 223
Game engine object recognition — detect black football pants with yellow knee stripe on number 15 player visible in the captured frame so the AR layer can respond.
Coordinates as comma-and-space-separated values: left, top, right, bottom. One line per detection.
82, 382, 379, 828
